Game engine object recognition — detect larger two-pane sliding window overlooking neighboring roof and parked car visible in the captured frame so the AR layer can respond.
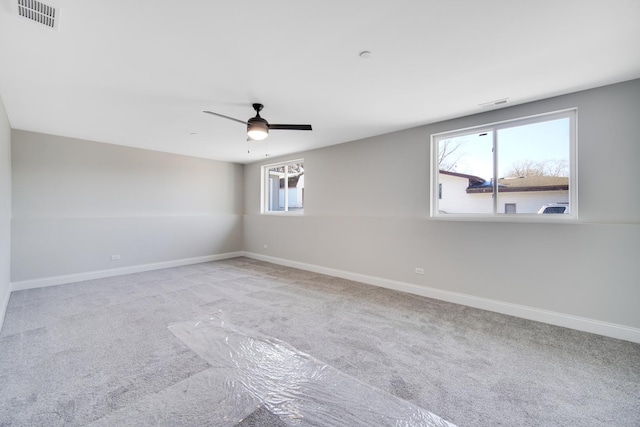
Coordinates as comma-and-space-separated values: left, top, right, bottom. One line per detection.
431, 109, 577, 220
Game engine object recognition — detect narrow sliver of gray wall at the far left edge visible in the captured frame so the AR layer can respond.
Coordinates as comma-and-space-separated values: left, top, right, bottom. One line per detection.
0, 97, 11, 329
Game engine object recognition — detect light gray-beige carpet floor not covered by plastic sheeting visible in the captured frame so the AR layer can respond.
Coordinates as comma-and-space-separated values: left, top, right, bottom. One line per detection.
0, 258, 640, 426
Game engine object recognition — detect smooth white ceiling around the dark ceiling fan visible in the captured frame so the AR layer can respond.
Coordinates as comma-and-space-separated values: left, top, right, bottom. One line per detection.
0, 0, 640, 163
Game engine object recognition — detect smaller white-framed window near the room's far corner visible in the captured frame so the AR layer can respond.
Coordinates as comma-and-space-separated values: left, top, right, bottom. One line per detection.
262, 160, 304, 213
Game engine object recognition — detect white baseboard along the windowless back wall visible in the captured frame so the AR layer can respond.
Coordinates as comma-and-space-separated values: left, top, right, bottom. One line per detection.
11, 252, 244, 292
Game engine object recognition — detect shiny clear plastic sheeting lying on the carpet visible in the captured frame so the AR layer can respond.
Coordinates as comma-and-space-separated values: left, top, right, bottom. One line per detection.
169, 315, 455, 427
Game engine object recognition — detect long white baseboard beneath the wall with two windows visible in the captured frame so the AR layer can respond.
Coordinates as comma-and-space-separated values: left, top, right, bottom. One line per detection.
244, 252, 640, 343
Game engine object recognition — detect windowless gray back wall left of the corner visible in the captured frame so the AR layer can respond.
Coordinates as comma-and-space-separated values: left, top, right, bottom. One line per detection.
11, 130, 243, 282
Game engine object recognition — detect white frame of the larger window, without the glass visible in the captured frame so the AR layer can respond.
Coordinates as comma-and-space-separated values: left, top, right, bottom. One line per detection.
430, 108, 578, 222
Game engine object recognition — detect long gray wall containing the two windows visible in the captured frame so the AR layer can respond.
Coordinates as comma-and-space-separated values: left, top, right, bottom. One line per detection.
244, 80, 640, 328
